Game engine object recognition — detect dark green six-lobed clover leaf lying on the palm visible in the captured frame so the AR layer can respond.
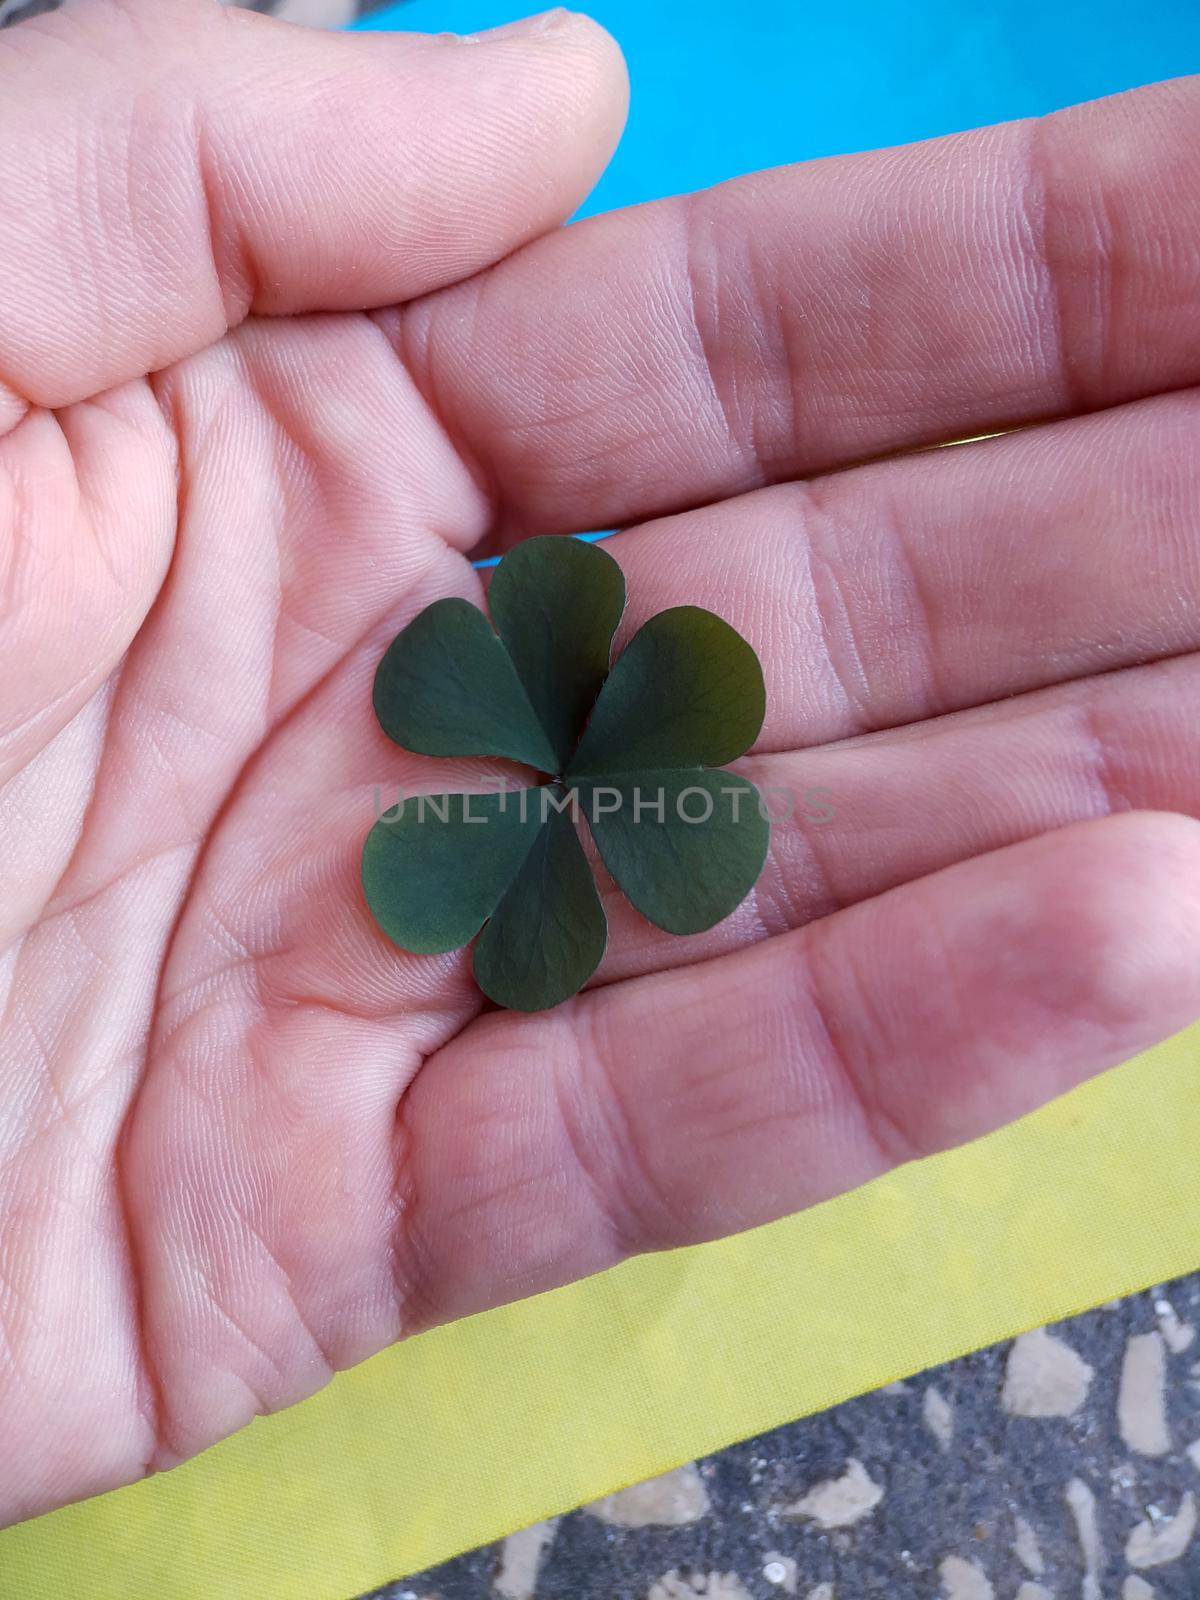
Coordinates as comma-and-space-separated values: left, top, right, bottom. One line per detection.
363, 536, 770, 1011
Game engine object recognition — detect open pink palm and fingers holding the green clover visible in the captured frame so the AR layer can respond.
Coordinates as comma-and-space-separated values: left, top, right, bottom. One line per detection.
0, 0, 1200, 1518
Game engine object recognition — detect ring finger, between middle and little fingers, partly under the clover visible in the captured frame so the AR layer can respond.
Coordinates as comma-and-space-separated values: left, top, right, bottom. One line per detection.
595, 654, 1200, 984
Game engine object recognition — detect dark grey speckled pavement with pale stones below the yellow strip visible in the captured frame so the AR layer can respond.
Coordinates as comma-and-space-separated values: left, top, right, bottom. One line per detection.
364, 1275, 1200, 1600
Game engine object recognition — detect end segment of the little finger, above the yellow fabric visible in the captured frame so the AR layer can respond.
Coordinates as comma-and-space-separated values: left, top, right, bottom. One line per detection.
812, 813, 1200, 1154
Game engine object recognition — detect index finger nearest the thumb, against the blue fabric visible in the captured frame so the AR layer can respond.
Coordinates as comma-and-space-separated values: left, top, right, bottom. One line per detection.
400, 80, 1200, 536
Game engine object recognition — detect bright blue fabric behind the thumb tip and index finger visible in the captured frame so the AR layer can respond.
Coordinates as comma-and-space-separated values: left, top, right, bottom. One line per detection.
360, 0, 1200, 213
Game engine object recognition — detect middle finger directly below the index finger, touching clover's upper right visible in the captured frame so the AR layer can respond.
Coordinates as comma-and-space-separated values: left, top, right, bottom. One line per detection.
605, 390, 1200, 750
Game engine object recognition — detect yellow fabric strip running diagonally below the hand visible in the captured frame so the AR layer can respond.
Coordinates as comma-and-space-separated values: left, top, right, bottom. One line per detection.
0, 1029, 1200, 1600
